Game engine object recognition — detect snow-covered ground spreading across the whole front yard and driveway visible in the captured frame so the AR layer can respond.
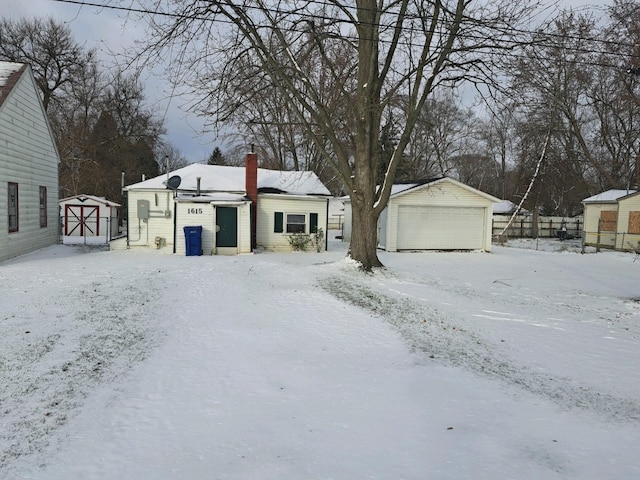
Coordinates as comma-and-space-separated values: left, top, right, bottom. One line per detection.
0, 234, 640, 480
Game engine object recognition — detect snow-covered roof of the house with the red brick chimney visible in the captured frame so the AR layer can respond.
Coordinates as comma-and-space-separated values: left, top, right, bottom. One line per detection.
125, 163, 331, 195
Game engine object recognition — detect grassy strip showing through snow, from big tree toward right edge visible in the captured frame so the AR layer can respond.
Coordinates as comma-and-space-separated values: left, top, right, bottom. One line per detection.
319, 272, 640, 421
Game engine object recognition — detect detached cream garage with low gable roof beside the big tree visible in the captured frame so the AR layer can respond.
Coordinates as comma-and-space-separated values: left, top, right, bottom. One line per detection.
344, 178, 500, 252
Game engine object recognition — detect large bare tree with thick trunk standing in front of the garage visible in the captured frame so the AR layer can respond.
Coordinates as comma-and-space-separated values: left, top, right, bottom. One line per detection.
127, 0, 544, 269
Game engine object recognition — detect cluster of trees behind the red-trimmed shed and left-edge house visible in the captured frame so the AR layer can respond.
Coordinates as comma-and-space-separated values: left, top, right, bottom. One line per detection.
0, 18, 186, 203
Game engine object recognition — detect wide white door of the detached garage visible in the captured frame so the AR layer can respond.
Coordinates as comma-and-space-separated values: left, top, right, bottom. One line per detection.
398, 205, 485, 250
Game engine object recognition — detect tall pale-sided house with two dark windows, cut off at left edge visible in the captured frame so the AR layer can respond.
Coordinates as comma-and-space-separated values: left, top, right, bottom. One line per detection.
0, 62, 60, 261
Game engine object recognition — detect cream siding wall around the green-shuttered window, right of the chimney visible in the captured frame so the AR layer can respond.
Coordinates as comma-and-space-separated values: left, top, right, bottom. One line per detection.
256, 194, 328, 251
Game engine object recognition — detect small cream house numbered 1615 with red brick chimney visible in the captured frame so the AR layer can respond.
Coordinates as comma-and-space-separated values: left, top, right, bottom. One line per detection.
125, 153, 330, 255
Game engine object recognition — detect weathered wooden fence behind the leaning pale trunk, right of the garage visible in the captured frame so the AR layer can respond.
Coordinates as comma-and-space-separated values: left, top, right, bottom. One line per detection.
491, 215, 584, 239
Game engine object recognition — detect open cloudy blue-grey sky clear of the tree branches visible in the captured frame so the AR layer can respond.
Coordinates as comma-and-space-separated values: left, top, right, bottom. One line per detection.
0, 0, 611, 162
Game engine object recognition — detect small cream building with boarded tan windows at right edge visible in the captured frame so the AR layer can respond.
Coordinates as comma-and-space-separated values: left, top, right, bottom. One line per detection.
582, 190, 640, 250
